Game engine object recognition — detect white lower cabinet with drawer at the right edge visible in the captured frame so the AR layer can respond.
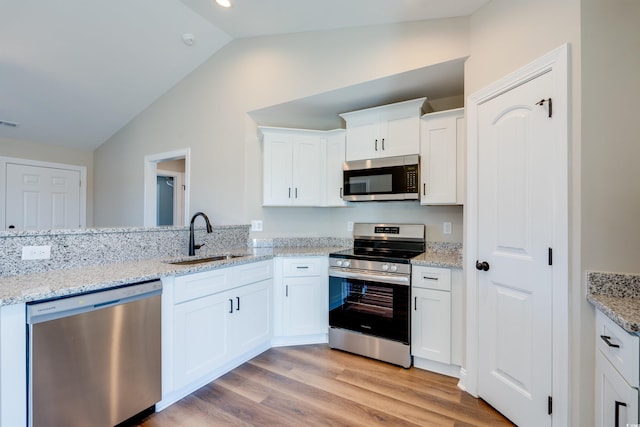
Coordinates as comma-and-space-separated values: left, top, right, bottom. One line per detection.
595, 311, 640, 427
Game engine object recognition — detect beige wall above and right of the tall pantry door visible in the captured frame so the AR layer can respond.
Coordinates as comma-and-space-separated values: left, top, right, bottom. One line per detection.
465, 0, 640, 426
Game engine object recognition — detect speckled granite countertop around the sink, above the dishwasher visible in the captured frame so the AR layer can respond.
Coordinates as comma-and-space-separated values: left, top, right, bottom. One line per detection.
0, 247, 344, 306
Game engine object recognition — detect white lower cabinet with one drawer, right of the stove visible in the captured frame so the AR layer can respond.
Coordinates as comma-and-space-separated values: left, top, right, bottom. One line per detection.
411, 265, 464, 377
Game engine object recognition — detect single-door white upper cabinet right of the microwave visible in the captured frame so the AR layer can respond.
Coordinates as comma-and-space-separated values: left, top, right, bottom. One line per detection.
420, 108, 465, 205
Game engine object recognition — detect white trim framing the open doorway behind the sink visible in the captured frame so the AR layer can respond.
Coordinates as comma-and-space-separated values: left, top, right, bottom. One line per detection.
144, 148, 191, 227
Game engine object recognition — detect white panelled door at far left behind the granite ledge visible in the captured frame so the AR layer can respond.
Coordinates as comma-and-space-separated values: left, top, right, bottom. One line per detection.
5, 163, 83, 230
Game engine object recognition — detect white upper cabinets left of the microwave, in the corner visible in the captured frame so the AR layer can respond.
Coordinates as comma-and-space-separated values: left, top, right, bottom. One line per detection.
259, 126, 344, 206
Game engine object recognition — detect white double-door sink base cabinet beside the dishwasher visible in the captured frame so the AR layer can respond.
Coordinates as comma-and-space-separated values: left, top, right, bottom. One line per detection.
158, 260, 273, 409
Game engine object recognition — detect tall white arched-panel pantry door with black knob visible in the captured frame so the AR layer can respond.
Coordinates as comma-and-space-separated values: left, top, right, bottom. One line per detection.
476, 72, 555, 427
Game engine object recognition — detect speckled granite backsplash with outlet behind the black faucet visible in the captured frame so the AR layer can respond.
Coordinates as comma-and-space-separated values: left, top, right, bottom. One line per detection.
0, 225, 250, 277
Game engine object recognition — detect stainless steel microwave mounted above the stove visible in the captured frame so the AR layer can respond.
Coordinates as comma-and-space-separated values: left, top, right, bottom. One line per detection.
342, 154, 420, 202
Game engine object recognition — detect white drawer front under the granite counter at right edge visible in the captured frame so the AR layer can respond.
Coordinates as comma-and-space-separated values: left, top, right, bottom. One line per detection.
596, 310, 640, 388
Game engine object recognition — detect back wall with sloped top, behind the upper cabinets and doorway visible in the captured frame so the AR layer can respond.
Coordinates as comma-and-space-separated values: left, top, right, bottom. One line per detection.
95, 18, 469, 241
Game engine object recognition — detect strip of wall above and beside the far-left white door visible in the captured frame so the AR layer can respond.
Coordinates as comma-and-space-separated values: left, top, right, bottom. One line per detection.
0, 137, 93, 227
